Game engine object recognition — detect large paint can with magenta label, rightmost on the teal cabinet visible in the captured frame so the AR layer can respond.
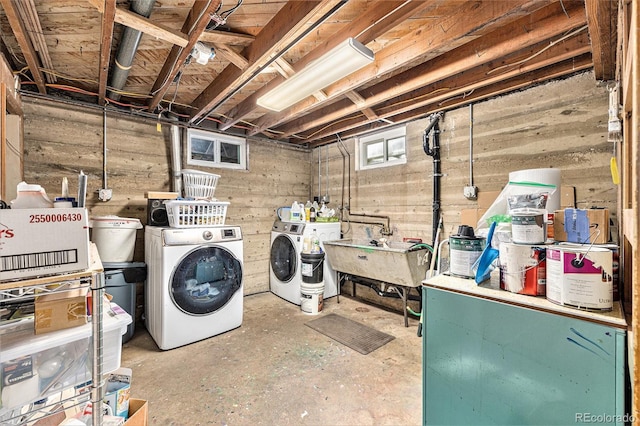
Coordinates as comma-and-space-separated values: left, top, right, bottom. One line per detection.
547, 244, 613, 311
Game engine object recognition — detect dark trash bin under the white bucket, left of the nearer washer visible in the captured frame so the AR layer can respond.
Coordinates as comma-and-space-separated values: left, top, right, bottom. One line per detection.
102, 262, 147, 343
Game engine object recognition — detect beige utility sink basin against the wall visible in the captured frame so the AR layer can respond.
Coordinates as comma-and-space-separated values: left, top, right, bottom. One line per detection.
323, 239, 428, 287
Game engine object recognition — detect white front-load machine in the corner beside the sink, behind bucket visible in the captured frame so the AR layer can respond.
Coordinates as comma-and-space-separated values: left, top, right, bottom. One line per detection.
269, 220, 340, 305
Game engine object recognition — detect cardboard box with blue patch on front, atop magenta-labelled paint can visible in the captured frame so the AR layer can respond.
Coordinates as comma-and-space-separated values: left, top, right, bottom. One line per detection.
553, 209, 609, 244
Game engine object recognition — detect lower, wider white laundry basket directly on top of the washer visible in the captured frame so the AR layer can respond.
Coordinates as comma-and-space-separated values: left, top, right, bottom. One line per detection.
165, 200, 231, 228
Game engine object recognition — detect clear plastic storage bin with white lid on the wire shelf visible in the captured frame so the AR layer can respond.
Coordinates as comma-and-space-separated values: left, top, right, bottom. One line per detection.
0, 304, 131, 420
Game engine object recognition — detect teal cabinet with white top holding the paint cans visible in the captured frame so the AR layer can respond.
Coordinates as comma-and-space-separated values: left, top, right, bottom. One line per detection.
422, 277, 626, 425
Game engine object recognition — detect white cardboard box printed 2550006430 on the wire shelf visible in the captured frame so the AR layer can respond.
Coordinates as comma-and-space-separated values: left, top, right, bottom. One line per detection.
0, 208, 89, 281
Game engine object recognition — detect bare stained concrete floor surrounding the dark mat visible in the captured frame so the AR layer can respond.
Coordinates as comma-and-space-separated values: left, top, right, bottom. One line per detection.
121, 293, 422, 426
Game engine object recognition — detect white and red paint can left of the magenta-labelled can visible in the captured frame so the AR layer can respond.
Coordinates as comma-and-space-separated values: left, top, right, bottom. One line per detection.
500, 243, 547, 296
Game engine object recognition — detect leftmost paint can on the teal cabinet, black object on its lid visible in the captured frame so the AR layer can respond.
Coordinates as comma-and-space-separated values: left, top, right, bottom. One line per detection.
449, 225, 485, 278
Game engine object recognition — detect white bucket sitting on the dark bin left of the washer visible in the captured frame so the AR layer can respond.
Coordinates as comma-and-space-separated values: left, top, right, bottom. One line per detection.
89, 216, 142, 263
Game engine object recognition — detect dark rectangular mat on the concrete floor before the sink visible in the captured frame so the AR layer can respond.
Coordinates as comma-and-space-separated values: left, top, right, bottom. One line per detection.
305, 314, 395, 355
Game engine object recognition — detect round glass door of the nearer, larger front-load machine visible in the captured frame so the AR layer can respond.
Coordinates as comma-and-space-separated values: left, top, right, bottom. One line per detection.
169, 246, 242, 315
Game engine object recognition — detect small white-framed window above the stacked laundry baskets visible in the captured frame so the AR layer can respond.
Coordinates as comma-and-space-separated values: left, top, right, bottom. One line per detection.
187, 129, 247, 169
